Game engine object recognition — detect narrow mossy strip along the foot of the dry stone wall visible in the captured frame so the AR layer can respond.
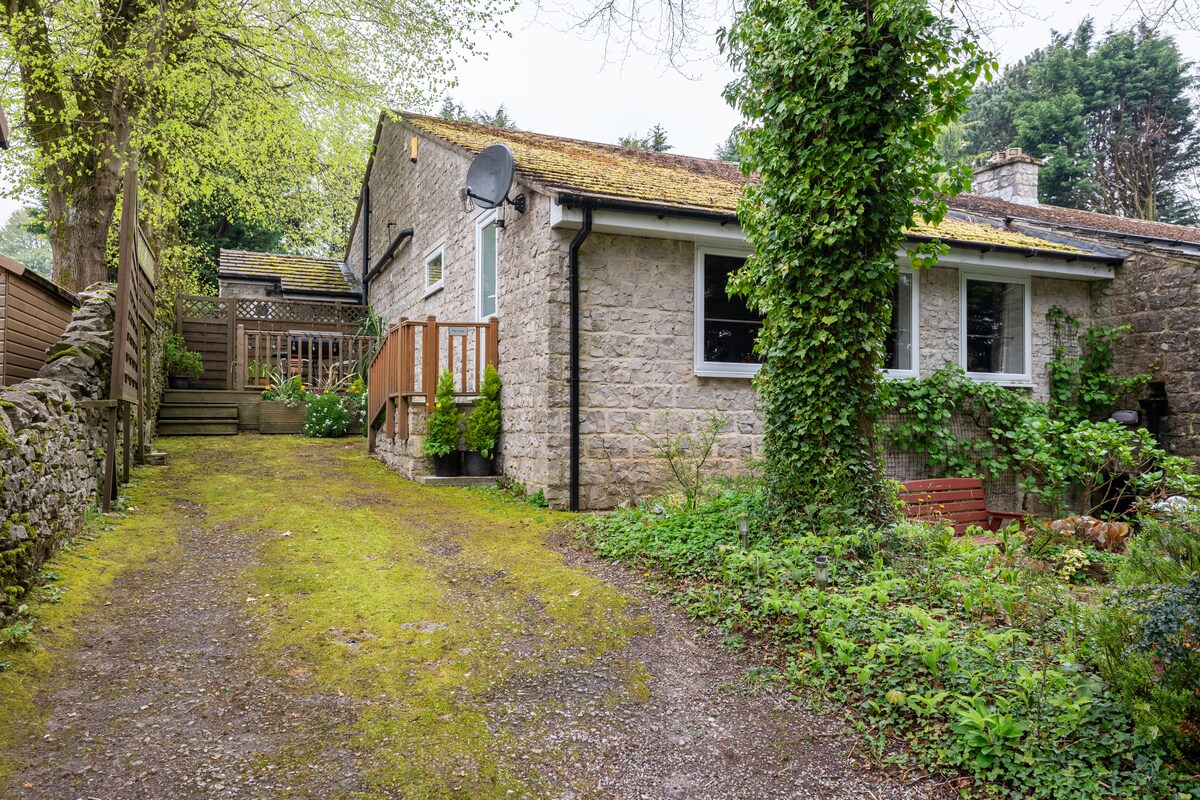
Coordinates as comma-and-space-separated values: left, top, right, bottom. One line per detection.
0, 469, 182, 786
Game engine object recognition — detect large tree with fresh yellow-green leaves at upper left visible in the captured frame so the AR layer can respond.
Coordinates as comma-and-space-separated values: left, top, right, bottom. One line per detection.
0, 0, 500, 287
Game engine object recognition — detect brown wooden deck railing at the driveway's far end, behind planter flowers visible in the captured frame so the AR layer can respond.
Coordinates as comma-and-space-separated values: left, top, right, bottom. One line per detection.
235, 325, 376, 387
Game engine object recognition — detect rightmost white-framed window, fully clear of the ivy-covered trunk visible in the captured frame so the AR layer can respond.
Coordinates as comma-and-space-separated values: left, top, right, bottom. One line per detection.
960, 273, 1032, 383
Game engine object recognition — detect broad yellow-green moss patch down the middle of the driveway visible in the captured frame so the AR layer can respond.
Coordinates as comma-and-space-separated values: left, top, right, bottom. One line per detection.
150, 435, 649, 800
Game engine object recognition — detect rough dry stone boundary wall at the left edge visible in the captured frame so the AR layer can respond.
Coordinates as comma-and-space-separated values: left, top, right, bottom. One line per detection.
0, 285, 116, 613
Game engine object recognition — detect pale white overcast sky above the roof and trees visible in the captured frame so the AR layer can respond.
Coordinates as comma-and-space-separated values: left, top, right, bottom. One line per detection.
0, 0, 1200, 221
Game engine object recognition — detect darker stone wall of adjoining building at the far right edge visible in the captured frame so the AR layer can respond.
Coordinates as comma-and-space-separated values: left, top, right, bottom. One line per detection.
1092, 240, 1200, 458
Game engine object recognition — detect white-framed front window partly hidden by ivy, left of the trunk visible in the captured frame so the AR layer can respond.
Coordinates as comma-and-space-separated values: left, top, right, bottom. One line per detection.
695, 248, 762, 378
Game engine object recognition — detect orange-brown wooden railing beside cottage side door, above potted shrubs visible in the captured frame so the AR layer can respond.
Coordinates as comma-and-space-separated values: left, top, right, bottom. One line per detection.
367, 317, 499, 451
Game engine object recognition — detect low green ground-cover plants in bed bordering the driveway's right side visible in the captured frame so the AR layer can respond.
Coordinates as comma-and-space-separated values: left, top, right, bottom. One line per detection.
582, 491, 1200, 800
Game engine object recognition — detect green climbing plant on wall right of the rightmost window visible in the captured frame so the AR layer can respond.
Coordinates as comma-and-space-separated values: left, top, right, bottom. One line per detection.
1046, 306, 1153, 421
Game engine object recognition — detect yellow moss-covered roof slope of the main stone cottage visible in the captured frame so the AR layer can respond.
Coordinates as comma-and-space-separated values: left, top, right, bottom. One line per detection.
400, 114, 1086, 254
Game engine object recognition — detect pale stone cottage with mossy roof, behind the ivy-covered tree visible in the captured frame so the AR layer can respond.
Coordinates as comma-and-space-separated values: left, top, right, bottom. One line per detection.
346, 114, 1123, 509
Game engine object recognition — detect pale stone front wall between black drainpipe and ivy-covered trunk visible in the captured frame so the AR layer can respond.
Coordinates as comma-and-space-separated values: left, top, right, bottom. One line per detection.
559, 234, 762, 509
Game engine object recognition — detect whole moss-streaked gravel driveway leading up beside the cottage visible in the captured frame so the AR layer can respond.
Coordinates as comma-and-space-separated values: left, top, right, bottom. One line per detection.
0, 435, 954, 800
